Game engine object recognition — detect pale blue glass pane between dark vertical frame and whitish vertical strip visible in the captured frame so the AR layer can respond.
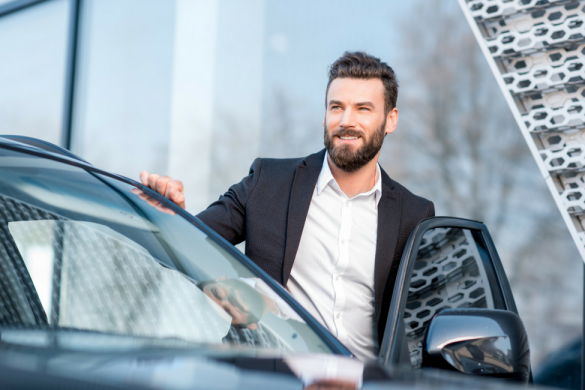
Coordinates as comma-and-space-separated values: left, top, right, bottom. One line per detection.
72, 0, 175, 177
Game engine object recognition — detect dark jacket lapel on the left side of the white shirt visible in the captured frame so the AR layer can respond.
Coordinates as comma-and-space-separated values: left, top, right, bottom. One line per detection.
281, 149, 325, 286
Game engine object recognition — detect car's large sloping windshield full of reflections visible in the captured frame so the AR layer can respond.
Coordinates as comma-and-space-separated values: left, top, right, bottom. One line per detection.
0, 149, 331, 353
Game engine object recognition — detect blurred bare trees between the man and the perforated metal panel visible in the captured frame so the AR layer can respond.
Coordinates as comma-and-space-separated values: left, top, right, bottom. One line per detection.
380, 0, 583, 364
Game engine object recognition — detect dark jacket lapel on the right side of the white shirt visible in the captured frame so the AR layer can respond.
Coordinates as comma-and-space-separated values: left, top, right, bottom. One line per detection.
374, 170, 402, 326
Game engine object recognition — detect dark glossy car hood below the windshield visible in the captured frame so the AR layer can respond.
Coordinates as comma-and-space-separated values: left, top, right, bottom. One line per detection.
0, 329, 548, 390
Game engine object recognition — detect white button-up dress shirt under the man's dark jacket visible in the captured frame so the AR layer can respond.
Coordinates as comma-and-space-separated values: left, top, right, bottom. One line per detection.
286, 154, 382, 360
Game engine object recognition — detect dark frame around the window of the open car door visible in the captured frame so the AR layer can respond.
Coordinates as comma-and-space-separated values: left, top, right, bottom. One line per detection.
379, 217, 518, 366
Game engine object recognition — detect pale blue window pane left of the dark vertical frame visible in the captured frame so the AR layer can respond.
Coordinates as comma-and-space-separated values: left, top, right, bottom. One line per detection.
0, 0, 69, 144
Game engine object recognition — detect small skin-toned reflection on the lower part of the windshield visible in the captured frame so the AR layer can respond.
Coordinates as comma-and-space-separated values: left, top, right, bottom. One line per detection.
203, 282, 255, 328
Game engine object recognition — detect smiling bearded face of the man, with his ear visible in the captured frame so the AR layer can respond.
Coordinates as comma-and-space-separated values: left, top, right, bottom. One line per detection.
323, 78, 398, 172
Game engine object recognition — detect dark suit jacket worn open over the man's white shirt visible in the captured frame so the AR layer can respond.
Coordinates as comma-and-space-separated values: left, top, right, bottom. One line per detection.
197, 150, 435, 342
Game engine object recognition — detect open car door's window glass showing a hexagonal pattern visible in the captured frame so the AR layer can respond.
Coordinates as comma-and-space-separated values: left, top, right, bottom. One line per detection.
404, 227, 505, 367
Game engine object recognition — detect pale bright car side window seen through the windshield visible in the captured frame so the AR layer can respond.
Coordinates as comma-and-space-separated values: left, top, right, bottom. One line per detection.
8, 220, 231, 344
